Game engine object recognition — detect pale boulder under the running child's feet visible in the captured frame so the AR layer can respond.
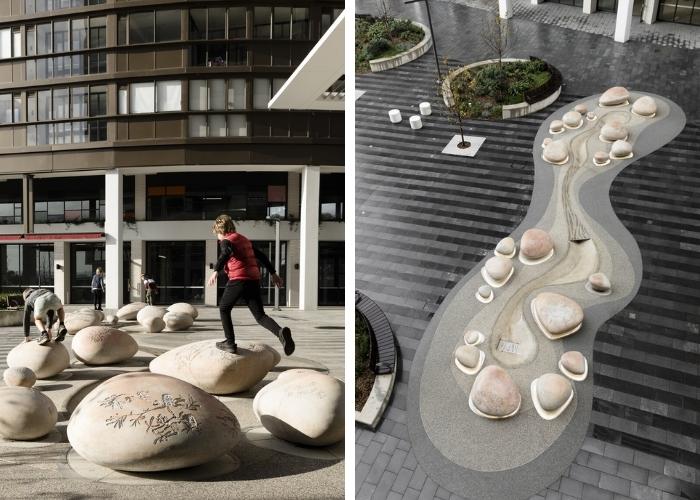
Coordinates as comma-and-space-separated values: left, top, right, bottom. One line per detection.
149, 340, 281, 394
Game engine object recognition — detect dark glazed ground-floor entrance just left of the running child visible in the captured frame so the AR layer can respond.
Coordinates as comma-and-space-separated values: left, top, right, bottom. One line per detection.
144, 241, 205, 304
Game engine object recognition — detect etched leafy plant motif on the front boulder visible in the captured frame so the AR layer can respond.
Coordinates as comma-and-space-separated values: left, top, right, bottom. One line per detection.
100, 391, 200, 444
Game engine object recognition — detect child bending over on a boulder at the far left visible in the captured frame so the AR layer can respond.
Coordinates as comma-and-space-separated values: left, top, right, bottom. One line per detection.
22, 288, 68, 345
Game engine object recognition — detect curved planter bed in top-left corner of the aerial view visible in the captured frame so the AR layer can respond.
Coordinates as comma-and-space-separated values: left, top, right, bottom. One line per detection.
355, 16, 432, 73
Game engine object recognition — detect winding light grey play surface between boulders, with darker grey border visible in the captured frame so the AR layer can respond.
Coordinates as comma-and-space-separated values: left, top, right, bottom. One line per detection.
407, 93, 685, 499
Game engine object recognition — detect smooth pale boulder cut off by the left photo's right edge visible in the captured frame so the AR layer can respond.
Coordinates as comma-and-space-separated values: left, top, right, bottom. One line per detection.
253, 369, 345, 446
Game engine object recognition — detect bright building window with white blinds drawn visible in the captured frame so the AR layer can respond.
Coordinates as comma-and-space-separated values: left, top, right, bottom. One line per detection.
124, 80, 182, 114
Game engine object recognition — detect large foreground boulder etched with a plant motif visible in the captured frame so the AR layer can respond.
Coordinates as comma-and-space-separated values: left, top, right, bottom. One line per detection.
68, 373, 241, 471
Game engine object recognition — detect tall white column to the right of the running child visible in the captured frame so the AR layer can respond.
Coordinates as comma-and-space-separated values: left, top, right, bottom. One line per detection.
299, 167, 321, 311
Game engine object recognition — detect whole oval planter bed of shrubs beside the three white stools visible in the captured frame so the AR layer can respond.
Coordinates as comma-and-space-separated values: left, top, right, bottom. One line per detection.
442, 58, 561, 120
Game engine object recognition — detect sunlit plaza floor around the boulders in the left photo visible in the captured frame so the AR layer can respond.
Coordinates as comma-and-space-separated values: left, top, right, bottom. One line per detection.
0, 306, 345, 499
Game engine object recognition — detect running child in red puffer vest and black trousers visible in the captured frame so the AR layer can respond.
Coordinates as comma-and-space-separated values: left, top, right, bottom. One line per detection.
208, 215, 294, 356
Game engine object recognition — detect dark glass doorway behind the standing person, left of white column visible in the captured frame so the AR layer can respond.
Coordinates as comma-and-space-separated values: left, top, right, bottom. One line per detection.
69, 243, 104, 304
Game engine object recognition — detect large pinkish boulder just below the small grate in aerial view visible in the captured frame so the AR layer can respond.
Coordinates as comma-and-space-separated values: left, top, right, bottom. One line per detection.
469, 365, 522, 419
